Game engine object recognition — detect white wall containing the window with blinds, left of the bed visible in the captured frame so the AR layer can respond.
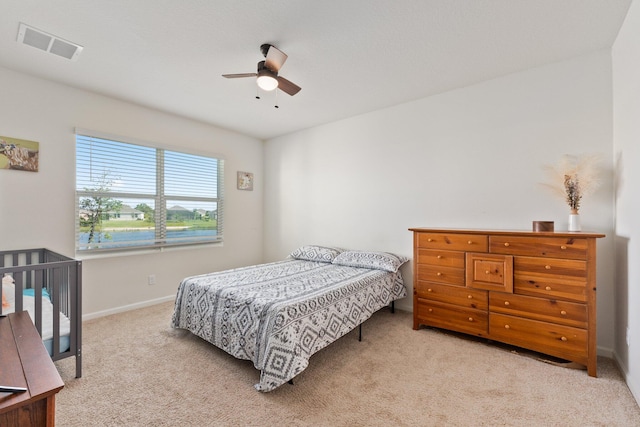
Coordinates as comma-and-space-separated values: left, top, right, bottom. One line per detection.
0, 68, 263, 317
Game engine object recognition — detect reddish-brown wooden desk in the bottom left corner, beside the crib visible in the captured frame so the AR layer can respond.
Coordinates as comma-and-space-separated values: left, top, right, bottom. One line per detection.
0, 311, 64, 427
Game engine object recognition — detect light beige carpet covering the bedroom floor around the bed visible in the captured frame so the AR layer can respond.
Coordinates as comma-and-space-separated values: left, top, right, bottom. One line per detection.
56, 303, 640, 427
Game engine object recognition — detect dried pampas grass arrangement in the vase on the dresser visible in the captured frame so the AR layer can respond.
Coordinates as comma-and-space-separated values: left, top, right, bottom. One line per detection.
543, 154, 601, 214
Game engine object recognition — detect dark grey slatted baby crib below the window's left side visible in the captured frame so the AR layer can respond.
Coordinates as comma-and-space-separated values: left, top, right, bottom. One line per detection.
0, 248, 82, 378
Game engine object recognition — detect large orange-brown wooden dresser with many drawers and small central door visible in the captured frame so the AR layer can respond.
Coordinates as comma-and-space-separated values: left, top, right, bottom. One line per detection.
409, 228, 605, 377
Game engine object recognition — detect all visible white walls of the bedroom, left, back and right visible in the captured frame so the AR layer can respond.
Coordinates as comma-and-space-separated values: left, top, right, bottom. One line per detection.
0, 37, 640, 404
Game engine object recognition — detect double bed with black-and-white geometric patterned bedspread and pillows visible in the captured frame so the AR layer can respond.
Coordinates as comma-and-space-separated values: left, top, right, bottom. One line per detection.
171, 245, 407, 392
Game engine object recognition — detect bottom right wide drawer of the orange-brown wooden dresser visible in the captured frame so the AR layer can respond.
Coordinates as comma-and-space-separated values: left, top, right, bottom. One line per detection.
489, 313, 587, 364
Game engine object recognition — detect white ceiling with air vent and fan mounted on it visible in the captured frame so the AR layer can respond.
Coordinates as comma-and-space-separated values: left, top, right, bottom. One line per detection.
0, 0, 631, 139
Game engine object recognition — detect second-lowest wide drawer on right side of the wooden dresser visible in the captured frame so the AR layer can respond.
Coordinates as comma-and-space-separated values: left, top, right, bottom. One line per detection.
489, 292, 587, 329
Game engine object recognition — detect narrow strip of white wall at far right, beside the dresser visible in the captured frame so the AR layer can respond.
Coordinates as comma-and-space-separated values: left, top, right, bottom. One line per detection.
613, 2, 640, 402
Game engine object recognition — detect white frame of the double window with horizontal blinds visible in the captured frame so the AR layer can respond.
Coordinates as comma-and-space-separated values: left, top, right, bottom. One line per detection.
74, 128, 225, 256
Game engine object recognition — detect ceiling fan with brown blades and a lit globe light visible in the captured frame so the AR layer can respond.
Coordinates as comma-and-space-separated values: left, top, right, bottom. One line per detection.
222, 43, 302, 96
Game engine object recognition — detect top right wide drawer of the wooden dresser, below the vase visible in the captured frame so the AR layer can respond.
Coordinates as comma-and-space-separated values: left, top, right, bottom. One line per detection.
489, 236, 588, 260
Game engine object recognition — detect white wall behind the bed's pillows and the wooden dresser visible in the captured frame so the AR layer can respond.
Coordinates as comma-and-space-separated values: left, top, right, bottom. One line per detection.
264, 51, 614, 356
